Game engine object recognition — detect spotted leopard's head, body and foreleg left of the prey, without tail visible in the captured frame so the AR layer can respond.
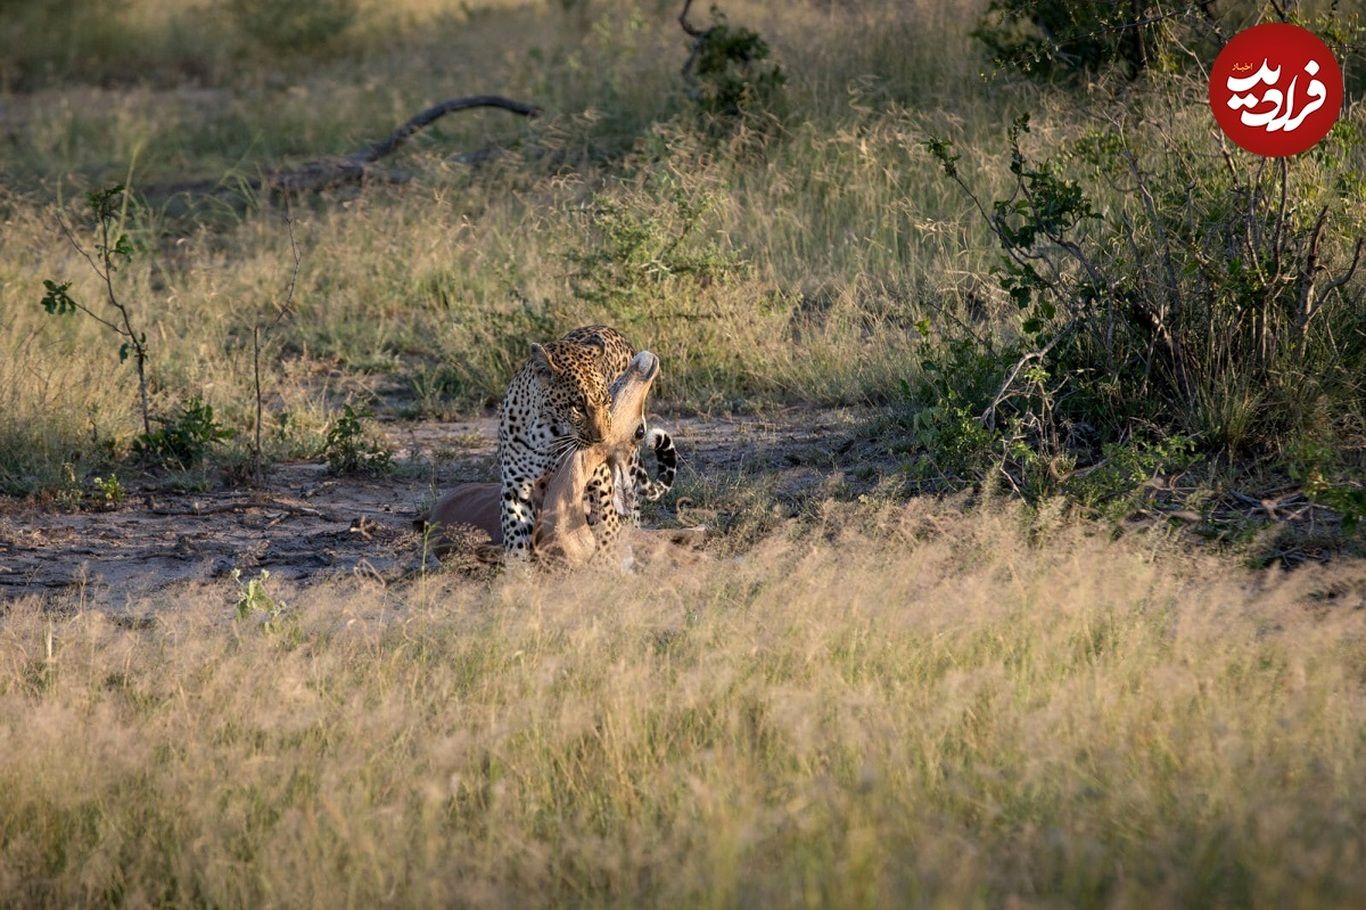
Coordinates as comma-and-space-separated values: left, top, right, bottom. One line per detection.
497, 325, 635, 560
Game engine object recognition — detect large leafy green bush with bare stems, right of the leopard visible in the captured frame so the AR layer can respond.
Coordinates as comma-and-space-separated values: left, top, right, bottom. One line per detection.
925, 67, 1366, 514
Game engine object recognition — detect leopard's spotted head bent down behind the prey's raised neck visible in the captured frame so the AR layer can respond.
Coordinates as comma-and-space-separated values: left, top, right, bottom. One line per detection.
531, 335, 612, 447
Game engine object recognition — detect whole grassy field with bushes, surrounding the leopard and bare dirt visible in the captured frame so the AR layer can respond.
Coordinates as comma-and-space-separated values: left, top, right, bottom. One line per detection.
0, 0, 1366, 907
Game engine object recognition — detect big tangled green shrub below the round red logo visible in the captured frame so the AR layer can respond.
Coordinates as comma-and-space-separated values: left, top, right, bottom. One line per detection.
928, 101, 1366, 452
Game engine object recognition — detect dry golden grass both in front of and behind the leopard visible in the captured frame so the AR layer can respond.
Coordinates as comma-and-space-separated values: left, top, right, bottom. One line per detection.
0, 0, 1366, 907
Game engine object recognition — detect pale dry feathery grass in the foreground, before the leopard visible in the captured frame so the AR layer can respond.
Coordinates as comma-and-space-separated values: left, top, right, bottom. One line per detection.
0, 500, 1366, 907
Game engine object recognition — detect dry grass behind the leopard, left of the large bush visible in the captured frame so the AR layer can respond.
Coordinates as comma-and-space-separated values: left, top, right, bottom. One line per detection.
0, 0, 1001, 493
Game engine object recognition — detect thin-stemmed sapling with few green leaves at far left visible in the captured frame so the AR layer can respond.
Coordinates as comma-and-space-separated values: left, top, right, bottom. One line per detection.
40, 183, 152, 435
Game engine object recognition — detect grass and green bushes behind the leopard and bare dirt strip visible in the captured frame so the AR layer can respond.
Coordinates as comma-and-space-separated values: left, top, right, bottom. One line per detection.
0, 0, 1366, 535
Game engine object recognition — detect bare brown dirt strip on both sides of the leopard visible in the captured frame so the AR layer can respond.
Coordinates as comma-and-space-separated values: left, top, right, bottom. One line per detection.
0, 409, 877, 608
